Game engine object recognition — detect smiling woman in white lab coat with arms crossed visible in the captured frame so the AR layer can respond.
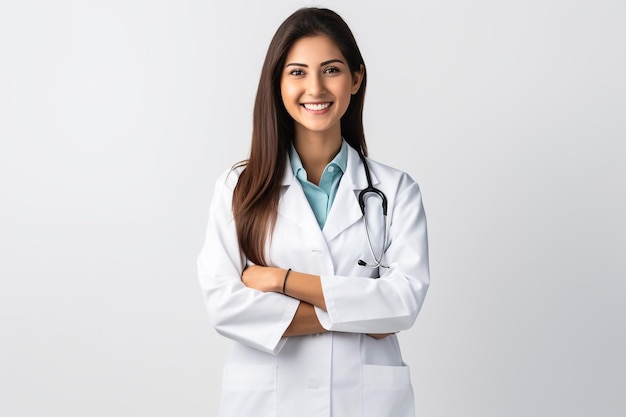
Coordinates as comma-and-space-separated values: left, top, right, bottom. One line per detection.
198, 8, 429, 417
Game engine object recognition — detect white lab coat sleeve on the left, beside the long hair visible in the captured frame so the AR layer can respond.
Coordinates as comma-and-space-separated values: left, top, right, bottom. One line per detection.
198, 172, 299, 355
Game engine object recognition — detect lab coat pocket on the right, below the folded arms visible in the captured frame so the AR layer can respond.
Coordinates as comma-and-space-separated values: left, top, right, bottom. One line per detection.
361, 365, 414, 417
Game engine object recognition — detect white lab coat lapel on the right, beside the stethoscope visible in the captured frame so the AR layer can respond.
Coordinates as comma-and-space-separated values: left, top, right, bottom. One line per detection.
323, 146, 377, 242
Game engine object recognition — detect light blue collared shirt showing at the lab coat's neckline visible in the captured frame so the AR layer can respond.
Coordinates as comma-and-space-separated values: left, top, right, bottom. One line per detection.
289, 140, 348, 229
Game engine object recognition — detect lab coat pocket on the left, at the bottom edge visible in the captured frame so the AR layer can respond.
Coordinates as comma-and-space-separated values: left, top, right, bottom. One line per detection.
220, 363, 276, 417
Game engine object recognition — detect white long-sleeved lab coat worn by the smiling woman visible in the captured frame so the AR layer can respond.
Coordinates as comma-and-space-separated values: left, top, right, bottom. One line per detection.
198, 147, 429, 417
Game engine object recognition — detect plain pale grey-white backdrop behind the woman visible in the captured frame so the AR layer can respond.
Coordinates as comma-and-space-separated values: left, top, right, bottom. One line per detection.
0, 0, 626, 417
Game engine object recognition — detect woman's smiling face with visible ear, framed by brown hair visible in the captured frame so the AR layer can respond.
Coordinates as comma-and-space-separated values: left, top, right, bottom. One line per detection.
280, 36, 363, 138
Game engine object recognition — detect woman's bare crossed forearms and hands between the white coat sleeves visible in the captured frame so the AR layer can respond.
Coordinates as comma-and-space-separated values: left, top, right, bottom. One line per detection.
241, 265, 391, 339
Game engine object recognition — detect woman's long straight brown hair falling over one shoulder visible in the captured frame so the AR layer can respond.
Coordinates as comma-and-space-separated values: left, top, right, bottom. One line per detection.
232, 8, 367, 265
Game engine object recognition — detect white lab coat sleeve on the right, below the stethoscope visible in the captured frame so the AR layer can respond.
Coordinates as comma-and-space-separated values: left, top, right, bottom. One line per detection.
316, 174, 430, 333
